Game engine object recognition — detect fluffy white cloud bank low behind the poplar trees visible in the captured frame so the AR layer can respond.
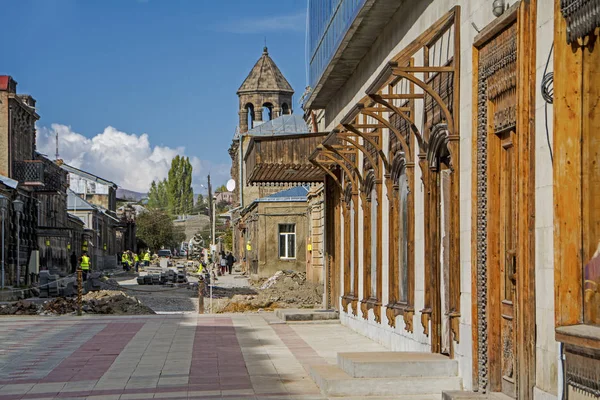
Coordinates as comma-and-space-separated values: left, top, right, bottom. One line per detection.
37, 124, 230, 193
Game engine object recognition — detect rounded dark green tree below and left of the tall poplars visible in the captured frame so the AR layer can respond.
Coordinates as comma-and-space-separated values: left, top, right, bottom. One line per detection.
136, 208, 180, 251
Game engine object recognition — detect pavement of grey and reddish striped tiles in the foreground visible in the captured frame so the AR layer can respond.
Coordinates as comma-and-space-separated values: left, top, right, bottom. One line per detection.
0, 313, 385, 400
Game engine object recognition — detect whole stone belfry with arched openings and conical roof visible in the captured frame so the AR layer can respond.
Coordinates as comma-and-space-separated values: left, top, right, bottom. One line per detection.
237, 47, 294, 133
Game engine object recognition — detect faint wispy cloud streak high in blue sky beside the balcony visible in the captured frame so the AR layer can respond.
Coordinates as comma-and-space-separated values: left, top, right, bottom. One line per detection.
218, 12, 306, 33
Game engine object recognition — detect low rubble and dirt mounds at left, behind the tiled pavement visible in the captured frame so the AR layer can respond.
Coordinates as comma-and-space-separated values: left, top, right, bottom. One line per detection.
40, 290, 155, 315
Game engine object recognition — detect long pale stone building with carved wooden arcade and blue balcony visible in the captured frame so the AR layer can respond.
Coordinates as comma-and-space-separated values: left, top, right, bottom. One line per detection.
246, 0, 576, 399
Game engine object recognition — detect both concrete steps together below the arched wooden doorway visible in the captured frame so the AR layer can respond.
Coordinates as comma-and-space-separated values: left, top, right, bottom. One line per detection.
310, 352, 462, 400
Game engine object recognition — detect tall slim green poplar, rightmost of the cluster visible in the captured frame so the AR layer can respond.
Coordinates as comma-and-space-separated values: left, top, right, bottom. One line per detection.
167, 156, 194, 215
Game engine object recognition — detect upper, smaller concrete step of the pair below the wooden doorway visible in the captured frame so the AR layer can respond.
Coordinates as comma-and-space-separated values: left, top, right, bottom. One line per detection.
337, 351, 458, 378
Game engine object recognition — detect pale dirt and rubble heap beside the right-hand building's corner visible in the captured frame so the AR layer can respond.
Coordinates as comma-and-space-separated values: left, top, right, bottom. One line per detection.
215, 271, 323, 313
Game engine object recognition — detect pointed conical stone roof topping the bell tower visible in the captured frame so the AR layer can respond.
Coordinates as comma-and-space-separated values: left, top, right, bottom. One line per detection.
237, 47, 294, 94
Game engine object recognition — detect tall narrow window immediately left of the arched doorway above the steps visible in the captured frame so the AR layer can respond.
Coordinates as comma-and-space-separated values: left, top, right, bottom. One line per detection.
398, 174, 408, 303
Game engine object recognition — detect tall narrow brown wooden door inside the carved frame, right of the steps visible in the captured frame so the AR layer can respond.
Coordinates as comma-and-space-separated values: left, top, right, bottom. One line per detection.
498, 130, 518, 398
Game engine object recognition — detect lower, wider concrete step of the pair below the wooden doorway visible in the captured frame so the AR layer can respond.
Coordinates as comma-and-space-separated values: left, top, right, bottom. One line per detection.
310, 365, 462, 398
